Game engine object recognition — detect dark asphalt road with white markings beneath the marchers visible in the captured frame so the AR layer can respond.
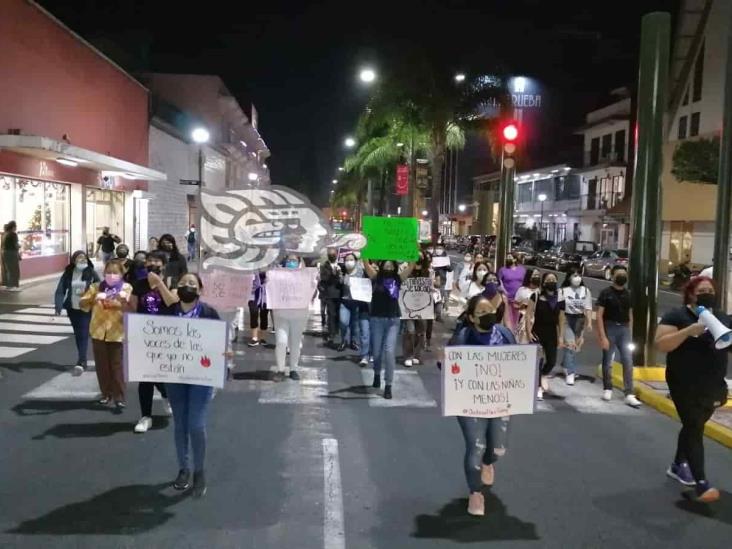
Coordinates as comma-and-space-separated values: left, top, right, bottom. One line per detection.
0, 288, 732, 549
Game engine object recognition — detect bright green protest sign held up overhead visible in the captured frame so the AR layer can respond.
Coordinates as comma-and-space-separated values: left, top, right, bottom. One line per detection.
361, 216, 419, 261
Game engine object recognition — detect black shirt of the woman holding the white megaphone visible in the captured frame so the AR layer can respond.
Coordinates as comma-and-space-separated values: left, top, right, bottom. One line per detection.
661, 307, 732, 386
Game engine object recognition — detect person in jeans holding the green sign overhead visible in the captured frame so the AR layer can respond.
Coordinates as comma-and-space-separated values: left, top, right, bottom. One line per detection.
364, 260, 416, 399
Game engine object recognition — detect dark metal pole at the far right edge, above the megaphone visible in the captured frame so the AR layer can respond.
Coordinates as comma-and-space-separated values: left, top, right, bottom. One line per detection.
713, 8, 732, 311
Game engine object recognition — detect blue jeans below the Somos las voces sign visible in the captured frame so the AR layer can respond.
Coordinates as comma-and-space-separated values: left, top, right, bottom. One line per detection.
165, 383, 213, 471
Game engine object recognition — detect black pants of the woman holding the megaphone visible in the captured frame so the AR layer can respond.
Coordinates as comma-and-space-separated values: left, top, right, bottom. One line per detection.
667, 378, 714, 481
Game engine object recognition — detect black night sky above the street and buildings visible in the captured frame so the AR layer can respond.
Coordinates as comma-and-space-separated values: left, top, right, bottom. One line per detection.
39, 0, 678, 203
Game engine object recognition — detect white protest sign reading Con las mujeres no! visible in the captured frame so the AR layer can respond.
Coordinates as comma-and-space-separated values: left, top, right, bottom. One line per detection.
442, 345, 538, 417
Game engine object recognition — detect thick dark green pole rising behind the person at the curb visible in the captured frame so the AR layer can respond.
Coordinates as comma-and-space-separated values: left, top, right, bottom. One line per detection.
629, 12, 671, 366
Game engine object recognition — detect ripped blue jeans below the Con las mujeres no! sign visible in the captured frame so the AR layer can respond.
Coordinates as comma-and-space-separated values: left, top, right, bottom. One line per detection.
457, 416, 509, 492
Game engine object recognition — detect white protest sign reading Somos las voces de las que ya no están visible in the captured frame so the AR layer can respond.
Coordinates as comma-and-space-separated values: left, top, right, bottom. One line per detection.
124, 314, 226, 389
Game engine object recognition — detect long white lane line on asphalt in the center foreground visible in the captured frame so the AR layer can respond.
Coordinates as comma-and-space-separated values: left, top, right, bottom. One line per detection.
323, 438, 346, 549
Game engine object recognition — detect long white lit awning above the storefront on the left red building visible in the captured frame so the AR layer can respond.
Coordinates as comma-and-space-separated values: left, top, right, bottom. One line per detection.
0, 135, 168, 181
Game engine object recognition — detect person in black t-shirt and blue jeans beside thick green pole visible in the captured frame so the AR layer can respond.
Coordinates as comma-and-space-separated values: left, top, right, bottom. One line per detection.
596, 265, 641, 408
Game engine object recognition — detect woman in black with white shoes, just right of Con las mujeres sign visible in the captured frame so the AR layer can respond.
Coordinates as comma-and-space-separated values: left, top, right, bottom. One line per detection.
526, 273, 564, 400
